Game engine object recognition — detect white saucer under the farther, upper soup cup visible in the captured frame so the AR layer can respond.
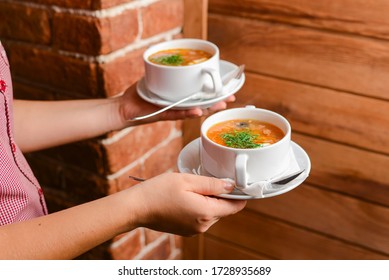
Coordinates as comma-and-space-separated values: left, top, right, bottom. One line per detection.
137, 60, 245, 110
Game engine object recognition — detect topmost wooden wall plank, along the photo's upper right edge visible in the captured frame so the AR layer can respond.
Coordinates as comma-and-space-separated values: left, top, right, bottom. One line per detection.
209, 0, 389, 39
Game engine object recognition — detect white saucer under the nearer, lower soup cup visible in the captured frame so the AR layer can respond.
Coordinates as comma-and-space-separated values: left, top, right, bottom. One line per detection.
177, 138, 311, 200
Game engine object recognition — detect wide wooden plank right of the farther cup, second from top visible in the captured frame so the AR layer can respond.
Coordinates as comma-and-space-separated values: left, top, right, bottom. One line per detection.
208, 15, 389, 100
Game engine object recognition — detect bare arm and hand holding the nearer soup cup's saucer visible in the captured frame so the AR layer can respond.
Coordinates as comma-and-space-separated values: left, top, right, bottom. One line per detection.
0, 173, 245, 259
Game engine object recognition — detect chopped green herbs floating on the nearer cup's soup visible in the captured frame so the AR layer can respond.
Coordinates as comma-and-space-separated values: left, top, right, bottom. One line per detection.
221, 130, 262, 149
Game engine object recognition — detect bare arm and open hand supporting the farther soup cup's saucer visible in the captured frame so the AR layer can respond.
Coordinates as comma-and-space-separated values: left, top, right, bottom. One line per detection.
14, 85, 235, 152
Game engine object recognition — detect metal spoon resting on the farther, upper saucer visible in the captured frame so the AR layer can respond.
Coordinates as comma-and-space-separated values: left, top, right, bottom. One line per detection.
128, 64, 245, 121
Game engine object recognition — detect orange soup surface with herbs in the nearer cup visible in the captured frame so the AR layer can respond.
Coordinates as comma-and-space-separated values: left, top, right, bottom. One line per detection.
207, 119, 285, 149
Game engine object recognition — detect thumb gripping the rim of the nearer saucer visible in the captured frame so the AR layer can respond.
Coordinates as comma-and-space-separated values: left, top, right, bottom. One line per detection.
187, 176, 235, 195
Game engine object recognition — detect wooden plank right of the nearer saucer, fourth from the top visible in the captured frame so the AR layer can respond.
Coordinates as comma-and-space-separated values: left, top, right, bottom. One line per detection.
293, 133, 389, 207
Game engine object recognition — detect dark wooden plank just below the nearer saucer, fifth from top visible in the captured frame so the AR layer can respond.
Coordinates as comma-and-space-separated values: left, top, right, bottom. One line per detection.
247, 184, 389, 256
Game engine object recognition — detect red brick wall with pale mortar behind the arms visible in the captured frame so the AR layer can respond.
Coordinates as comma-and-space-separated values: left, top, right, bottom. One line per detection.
0, 0, 183, 259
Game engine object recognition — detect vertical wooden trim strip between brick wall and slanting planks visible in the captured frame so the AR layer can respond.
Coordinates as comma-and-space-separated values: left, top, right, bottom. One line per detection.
182, 0, 208, 259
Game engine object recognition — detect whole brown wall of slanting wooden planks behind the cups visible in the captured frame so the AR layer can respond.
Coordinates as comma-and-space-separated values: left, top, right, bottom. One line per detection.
186, 0, 389, 259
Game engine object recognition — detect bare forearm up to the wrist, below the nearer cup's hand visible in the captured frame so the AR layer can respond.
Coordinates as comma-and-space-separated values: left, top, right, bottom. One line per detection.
0, 188, 137, 259
